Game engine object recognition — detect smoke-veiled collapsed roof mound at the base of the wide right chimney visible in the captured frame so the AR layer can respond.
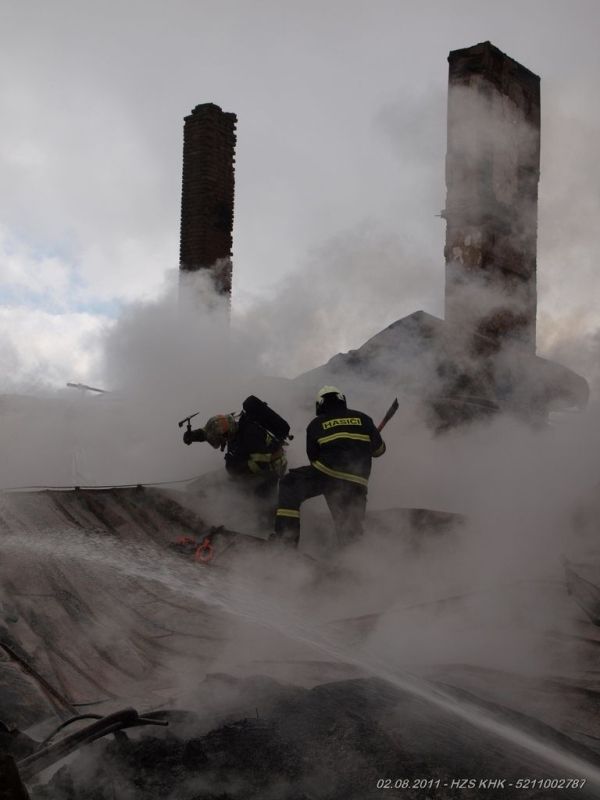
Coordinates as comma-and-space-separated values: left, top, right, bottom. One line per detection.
298, 311, 589, 428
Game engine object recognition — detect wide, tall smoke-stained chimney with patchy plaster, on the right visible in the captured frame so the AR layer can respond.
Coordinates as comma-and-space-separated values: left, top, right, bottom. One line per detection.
443, 42, 540, 352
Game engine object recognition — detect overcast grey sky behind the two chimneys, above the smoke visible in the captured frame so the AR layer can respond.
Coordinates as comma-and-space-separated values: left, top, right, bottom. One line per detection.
0, 0, 600, 380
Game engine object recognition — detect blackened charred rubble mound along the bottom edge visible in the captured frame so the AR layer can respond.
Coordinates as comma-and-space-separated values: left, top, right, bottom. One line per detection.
31, 676, 593, 800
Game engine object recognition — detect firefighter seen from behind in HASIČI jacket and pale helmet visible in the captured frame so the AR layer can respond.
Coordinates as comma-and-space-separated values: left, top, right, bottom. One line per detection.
271, 386, 385, 547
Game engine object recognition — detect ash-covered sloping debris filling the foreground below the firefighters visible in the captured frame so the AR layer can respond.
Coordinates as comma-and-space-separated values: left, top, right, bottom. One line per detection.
0, 466, 600, 800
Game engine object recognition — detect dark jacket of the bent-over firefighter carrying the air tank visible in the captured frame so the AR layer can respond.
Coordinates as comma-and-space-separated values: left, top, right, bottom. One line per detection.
225, 414, 287, 476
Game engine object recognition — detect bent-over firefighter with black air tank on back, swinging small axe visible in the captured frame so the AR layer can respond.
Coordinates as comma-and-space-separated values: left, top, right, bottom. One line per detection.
183, 395, 292, 500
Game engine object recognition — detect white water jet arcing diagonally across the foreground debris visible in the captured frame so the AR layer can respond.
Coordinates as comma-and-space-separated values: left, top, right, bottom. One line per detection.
0, 530, 600, 791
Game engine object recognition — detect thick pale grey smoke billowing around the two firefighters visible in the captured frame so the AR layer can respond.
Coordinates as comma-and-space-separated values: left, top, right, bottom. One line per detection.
0, 32, 600, 792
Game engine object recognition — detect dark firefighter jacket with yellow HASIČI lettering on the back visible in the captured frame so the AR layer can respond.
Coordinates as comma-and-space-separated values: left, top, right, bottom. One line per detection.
306, 408, 385, 486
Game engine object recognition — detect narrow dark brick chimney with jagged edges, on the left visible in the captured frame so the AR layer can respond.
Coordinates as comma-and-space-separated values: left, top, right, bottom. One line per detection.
179, 103, 237, 296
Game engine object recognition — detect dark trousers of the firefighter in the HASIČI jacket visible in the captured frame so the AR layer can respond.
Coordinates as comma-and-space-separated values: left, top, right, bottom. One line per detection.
275, 465, 367, 545
